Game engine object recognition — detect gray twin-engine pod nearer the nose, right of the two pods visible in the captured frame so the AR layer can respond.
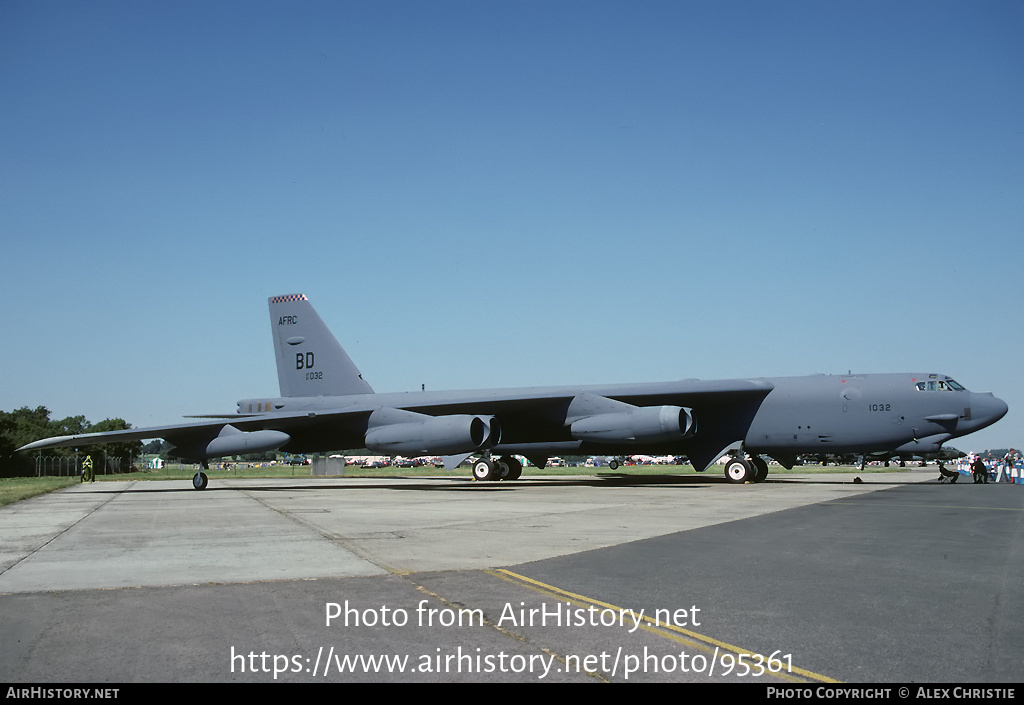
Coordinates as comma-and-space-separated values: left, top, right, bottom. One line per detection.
569, 406, 693, 444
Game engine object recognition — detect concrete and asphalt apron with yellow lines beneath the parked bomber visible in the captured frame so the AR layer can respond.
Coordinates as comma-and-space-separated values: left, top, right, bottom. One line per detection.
0, 468, 1024, 683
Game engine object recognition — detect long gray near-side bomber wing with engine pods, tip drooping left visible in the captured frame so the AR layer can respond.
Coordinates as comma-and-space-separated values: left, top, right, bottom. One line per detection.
18, 379, 772, 471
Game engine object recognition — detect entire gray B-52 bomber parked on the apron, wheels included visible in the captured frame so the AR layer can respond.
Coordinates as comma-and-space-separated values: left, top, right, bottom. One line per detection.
19, 294, 1007, 490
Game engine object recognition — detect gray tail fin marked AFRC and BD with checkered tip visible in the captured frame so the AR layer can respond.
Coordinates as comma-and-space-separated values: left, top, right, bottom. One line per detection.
269, 294, 374, 397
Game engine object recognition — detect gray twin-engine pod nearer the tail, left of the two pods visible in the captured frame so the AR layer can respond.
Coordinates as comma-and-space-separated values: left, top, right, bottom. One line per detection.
366, 409, 501, 455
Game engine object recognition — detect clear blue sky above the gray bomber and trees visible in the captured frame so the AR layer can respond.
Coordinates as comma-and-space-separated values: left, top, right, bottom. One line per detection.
0, 0, 1024, 450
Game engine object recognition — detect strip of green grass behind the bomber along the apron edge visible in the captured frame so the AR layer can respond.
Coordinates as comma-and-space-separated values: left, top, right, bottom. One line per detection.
0, 464, 916, 506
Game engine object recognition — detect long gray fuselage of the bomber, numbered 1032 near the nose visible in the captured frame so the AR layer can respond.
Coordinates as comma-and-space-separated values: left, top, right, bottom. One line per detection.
236, 373, 1007, 469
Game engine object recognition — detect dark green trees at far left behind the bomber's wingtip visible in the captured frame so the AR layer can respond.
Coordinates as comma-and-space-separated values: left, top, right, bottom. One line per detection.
0, 407, 142, 478
